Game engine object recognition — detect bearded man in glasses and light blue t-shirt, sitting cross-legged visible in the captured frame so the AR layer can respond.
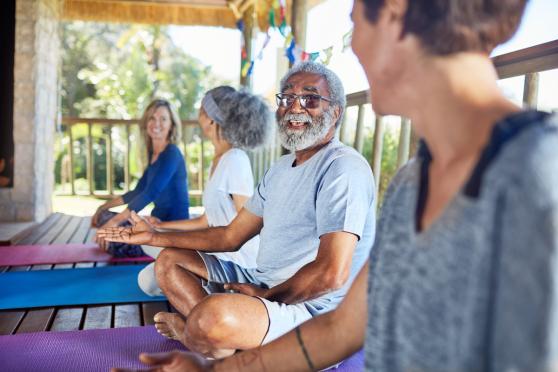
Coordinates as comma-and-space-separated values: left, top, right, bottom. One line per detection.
100, 62, 375, 358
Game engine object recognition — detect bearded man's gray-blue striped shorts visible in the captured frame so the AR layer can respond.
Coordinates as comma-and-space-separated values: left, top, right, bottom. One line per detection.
198, 252, 312, 344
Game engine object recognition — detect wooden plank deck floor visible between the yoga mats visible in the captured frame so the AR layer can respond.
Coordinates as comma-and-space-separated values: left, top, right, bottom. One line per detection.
0, 213, 170, 335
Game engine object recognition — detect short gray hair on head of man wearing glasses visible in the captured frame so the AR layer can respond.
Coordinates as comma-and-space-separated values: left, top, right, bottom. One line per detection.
280, 61, 347, 128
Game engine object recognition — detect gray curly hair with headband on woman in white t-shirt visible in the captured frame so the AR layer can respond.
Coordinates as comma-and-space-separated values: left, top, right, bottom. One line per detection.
206, 86, 273, 149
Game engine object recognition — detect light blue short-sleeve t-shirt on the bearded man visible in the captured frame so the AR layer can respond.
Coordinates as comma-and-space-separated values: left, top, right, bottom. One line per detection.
245, 139, 375, 315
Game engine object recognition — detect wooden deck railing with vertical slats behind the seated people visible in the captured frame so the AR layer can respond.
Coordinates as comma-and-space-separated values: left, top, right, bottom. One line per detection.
54, 40, 558, 203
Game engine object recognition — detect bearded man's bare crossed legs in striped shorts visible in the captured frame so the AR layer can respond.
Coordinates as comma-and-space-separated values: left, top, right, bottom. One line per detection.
155, 248, 312, 358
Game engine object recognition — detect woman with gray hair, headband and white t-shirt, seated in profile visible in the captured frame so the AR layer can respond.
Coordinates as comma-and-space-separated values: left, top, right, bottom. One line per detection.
138, 86, 273, 296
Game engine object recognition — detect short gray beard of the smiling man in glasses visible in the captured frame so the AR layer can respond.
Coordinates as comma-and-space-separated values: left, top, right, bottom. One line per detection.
277, 107, 333, 152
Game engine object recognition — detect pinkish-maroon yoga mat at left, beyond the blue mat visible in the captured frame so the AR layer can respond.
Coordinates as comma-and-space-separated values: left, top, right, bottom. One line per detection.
0, 243, 153, 266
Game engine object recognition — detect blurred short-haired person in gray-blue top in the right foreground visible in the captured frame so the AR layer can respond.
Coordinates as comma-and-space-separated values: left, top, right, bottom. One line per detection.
111, 0, 558, 372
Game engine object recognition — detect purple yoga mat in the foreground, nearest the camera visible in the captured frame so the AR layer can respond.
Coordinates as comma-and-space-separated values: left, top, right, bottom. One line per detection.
0, 326, 364, 372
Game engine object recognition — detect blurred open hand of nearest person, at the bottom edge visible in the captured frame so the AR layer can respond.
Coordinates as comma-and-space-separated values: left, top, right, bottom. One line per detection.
111, 350, 213, 372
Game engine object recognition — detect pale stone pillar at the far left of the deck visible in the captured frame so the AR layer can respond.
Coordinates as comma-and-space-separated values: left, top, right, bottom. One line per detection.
0, 0, 61, 222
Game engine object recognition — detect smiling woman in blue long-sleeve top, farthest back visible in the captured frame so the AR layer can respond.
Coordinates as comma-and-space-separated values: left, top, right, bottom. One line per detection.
92, 99, 189, 257
